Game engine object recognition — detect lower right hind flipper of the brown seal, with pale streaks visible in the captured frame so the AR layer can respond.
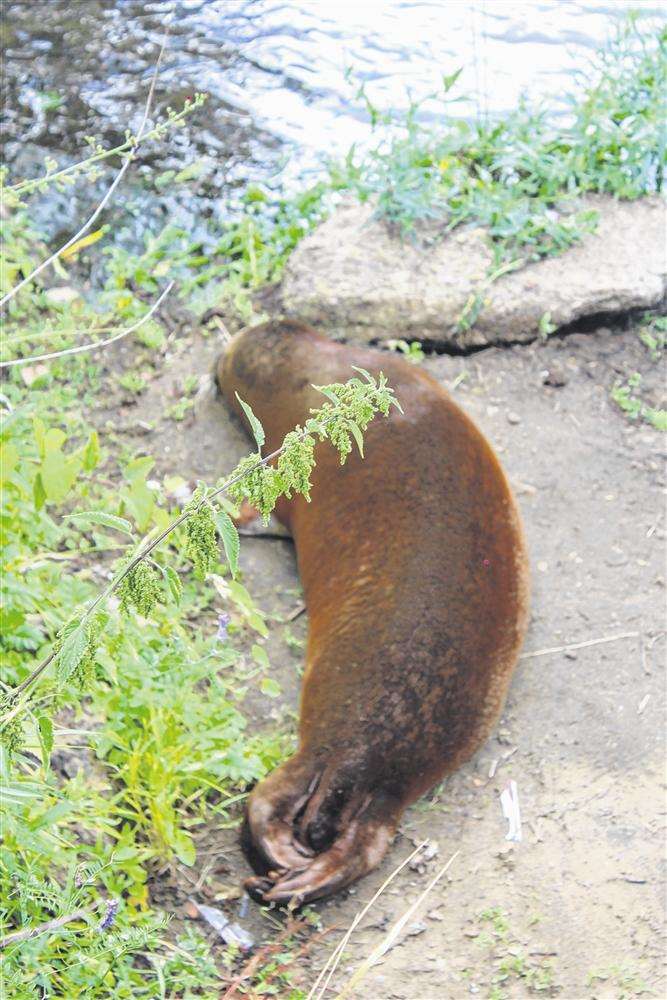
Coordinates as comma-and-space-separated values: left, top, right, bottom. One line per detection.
245, 816, 394, 906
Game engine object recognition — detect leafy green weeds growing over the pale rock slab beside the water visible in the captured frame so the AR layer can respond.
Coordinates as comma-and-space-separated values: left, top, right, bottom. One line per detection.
336, 17, 667, 269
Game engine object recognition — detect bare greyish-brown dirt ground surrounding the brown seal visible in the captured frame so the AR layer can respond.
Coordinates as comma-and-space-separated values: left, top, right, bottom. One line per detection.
96, 314, 667, 1000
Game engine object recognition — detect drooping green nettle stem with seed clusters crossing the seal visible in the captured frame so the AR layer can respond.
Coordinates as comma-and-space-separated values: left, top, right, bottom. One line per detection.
0, 369, 399, 759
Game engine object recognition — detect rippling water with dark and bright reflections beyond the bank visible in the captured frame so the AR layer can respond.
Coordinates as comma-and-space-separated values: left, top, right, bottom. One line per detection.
2, 0, 664, 242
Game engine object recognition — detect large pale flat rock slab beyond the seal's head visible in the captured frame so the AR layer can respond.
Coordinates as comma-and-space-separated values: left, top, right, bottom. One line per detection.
281, 195, 667, 349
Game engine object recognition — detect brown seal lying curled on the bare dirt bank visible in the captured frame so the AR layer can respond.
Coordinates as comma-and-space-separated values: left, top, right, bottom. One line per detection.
218, 322, 528, 902
